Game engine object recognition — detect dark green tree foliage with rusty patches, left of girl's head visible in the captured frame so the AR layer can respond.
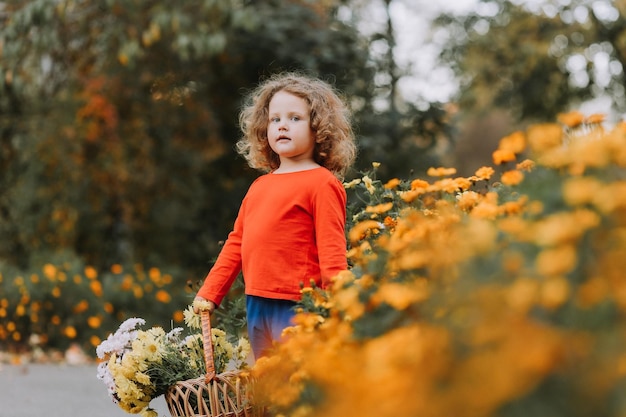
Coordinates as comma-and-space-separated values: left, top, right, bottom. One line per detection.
0, 0, 371, 277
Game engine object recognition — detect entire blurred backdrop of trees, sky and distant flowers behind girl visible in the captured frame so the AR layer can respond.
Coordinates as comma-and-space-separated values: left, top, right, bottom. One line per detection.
0, 0, 626, 356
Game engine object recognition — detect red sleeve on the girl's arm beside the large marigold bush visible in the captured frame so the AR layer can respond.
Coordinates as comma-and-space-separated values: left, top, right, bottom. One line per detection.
314, 178, 348, 288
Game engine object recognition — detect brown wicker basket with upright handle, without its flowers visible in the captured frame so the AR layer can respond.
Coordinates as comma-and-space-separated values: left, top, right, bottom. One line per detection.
165, 311, 263, 417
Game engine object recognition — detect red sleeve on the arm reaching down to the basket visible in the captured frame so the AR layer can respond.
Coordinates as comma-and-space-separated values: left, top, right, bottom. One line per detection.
198, 198, 246, 306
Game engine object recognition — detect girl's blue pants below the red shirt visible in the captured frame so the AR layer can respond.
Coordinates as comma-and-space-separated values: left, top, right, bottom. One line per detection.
246, 295, 296, 359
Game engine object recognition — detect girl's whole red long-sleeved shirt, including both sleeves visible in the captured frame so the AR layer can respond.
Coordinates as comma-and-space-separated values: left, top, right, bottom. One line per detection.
198, 168, 347, 305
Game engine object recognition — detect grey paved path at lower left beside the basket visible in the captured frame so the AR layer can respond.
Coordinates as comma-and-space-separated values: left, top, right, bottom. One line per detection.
0, 364, 170, 417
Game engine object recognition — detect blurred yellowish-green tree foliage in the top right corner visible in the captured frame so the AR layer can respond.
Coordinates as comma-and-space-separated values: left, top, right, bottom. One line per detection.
438, 0, 626, 121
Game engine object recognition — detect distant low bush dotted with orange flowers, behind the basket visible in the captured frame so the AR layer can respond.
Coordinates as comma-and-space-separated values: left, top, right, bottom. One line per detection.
0, 255, 193, 353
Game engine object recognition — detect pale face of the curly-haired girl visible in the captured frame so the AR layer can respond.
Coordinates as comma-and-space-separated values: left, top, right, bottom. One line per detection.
267, 91, 315, 165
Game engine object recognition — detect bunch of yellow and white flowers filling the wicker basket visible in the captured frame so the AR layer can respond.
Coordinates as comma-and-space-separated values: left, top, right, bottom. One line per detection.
96, 306, 250, 417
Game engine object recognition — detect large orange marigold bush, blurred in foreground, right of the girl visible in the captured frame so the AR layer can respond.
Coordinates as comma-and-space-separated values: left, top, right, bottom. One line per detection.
253, 114, 626, 417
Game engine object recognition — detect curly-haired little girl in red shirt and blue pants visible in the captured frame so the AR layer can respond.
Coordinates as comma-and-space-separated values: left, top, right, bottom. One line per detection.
196, 73, 356, 358
